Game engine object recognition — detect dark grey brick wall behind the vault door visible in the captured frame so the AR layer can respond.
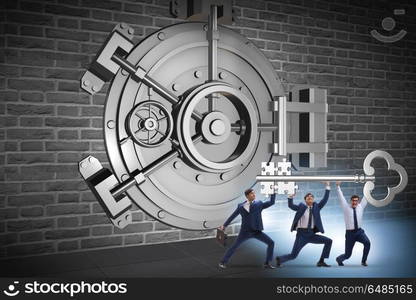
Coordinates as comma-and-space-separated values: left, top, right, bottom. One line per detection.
0, 0, 416, 257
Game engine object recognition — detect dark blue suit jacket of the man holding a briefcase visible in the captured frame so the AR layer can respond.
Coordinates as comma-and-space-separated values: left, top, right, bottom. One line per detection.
224, 194, 276, 231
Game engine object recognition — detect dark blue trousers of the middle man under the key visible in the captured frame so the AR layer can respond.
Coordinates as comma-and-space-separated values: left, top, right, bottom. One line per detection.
279, 230, 332, 263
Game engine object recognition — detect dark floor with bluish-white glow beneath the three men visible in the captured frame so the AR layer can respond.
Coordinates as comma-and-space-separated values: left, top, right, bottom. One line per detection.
0, 218, 416, 278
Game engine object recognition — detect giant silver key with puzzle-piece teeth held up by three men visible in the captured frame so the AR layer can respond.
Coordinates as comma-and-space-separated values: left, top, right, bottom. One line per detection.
256, 150, 408, 207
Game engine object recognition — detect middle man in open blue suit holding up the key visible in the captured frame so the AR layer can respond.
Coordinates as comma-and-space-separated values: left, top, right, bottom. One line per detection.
276, 182, 332, 267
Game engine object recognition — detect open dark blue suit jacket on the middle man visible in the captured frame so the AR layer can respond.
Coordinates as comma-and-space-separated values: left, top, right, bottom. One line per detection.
287, 190, 329, 233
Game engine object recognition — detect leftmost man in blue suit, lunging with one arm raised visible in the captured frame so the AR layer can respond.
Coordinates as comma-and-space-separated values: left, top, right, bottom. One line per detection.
219, 189, 276, 269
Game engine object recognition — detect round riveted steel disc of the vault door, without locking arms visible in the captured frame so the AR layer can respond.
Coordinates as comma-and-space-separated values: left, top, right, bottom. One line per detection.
96, 22, 284, 229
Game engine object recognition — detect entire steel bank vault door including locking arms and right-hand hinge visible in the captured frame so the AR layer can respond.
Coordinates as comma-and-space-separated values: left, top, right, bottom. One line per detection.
79, 5, 406, 230
